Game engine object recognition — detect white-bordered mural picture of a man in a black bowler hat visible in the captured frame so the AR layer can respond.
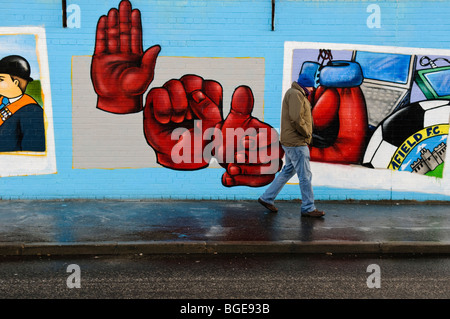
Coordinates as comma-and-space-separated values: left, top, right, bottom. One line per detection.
0, 27, 56, 176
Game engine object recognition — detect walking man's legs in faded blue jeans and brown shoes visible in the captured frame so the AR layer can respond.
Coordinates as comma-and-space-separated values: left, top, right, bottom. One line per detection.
260, 146, 316, 213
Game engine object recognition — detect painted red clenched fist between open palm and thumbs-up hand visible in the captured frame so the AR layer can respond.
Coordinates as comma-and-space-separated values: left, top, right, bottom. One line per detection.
144, 75, 223, 170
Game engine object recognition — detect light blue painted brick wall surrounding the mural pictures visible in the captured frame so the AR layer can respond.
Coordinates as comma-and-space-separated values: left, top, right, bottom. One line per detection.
0, 0, 450, 200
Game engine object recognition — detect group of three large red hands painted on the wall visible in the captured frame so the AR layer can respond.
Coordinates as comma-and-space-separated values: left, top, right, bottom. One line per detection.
91, 1, 283, 187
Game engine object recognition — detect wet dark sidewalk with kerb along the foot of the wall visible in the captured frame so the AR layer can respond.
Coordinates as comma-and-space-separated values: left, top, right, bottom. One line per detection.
0, 200, 450, 256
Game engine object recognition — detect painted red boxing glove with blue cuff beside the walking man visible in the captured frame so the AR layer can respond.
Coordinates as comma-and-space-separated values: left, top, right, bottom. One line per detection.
302, 61, 368, 164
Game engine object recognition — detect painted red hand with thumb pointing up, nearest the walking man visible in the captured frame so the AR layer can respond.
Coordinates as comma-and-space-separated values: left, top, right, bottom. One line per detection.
215, 86, 284, 187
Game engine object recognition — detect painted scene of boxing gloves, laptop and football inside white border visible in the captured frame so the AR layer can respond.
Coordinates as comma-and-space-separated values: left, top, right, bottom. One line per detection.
292, 48, 450, 184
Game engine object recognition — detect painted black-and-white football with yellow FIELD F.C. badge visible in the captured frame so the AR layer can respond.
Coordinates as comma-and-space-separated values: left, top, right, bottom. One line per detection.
363, 100, 450, 177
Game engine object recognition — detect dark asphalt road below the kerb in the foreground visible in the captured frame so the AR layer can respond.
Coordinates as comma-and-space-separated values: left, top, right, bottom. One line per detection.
0, 254, 450, 299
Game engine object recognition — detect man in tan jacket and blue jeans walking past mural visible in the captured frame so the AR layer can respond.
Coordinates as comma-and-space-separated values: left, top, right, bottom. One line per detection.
258, 74, 325, 217
